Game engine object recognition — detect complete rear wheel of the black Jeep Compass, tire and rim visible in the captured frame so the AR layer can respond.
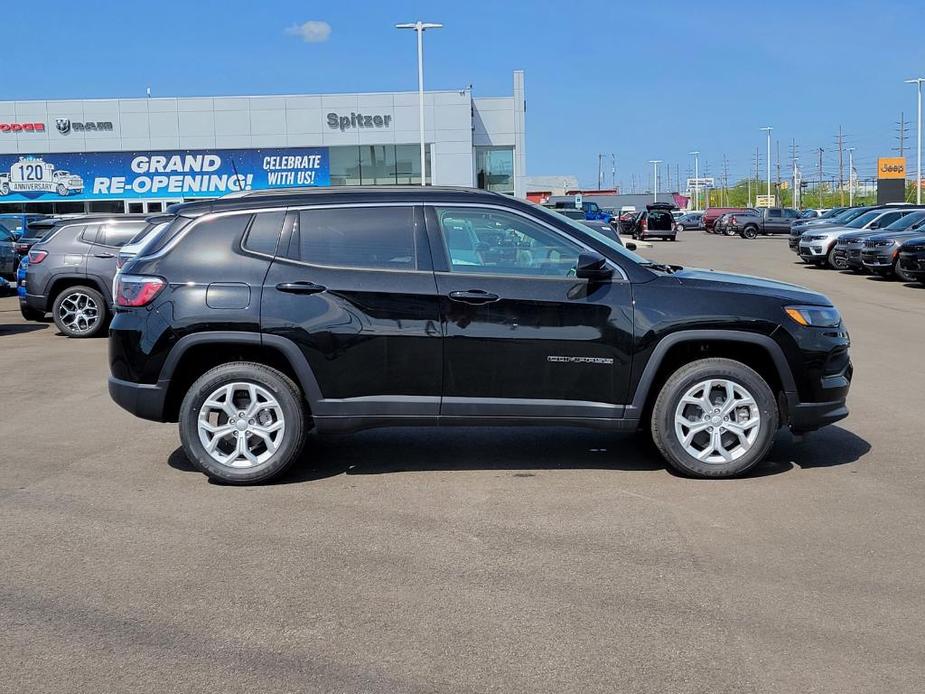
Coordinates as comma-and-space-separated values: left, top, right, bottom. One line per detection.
180, 362, 307, 484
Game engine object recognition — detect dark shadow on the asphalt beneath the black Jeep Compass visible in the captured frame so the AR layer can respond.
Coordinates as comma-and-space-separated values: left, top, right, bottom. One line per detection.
168, 427, 871, 484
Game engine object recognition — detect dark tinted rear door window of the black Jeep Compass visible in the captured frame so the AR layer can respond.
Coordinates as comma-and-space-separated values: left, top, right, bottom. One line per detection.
289, 206, 417, 270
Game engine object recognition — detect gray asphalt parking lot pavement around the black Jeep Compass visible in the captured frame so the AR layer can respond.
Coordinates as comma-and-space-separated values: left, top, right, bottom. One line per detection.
0, 232, 925, 692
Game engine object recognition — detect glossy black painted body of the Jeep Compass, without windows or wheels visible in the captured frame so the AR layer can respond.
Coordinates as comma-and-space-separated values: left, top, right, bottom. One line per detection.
110, 188, 851, 438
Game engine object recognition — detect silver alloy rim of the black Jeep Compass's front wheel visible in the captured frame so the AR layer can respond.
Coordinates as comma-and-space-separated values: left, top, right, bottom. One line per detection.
674, 379, 761, 463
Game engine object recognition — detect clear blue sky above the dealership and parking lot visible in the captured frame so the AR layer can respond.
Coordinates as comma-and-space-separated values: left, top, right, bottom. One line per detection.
0, 0, 925, 190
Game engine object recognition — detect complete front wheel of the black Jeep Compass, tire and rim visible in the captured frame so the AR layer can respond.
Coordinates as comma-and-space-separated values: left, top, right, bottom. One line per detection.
652, 358, 779, 477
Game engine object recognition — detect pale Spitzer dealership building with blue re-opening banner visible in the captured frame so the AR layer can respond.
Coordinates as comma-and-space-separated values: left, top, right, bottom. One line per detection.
0, 71, 526, 214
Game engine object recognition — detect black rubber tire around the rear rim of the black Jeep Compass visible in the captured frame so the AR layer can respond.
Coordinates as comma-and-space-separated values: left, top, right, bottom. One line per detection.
179, 362, 307, 484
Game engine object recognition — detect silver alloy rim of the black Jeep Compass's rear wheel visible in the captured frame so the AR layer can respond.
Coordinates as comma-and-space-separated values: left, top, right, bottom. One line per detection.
196, 383, 286, 468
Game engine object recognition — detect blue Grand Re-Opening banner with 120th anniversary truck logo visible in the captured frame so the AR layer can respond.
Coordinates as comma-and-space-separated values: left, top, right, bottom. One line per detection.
0, 147, 331, 202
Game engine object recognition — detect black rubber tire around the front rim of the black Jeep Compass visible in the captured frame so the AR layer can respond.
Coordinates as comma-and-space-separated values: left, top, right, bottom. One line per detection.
652, 358, 779, 477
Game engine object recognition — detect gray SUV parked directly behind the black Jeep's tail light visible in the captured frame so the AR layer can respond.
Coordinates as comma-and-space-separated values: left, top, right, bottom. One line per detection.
19, 215, 147, 337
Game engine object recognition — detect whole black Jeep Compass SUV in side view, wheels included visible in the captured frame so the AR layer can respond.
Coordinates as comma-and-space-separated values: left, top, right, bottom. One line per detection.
109, 187, 852, 483
